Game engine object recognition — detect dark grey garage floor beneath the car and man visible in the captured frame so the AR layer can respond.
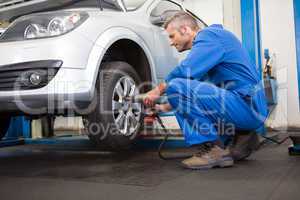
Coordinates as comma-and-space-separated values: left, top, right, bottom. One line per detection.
0, 137, 300, 200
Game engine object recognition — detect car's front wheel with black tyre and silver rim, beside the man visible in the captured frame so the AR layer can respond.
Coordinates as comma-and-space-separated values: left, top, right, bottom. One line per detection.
83, 62, 143, 151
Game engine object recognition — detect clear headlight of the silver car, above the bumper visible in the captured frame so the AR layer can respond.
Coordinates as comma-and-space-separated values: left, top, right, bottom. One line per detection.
0, 11, 88, 41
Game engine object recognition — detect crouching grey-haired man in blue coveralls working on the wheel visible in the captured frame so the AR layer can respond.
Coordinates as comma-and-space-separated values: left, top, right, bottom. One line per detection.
144, 12, 267, 169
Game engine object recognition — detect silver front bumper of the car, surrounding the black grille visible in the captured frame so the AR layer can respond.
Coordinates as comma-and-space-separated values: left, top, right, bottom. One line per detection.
0, 26, 105, 115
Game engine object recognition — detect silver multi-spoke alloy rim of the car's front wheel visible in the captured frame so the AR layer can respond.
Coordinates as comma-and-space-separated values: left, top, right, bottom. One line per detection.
112, 76, 142, 136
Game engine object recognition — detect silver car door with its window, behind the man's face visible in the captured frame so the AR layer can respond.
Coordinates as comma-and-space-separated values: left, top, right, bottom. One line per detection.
149, 0, 183, 81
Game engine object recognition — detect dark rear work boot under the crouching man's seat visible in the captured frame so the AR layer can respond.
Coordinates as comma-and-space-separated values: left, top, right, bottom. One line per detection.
229, 131, 259, 161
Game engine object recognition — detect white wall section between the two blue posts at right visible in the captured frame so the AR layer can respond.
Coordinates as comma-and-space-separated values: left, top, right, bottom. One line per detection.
260, 0, 300, 128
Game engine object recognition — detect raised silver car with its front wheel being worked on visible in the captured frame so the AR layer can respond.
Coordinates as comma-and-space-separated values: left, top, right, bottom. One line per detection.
0, 0, 204, 150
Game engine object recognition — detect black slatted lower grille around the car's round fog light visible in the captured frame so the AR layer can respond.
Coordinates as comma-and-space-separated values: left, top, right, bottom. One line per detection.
0, 61, 62, 91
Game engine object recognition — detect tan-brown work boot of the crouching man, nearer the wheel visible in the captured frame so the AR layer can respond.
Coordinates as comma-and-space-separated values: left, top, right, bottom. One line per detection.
182, 143, 233, 169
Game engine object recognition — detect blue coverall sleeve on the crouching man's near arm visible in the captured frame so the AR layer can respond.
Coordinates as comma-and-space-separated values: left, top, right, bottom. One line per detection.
165, 31, 225, 83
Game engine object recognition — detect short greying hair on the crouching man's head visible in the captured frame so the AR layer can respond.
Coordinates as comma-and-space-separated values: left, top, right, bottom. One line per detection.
164, 11, 199, 30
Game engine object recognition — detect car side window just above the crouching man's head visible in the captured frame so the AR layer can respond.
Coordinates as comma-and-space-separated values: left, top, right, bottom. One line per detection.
150, 0, 182, 17
